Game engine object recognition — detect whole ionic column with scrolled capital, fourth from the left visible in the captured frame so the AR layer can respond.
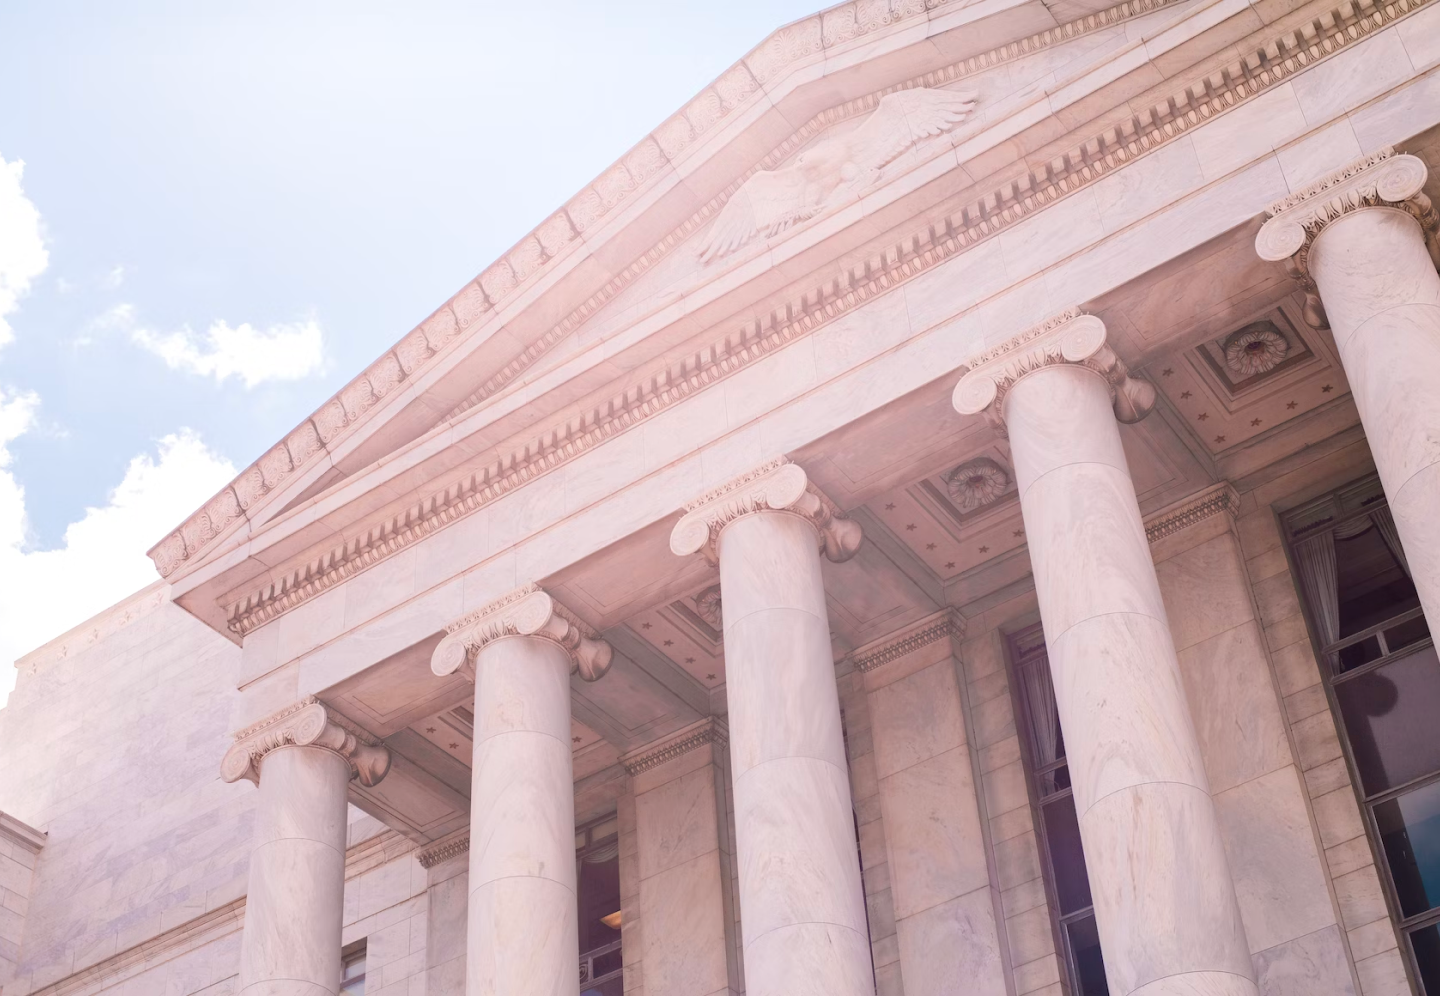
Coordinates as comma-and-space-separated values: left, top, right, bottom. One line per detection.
955, 311, 1257, 996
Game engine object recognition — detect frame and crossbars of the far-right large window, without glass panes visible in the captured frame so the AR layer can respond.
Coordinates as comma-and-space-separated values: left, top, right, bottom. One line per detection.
1276, 474, 1440, 996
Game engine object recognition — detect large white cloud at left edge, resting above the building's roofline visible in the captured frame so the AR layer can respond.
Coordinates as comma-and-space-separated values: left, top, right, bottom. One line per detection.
0, 405, 235, 705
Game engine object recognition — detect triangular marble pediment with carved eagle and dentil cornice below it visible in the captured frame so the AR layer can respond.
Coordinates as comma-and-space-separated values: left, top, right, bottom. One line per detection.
151, 0, 1418, 638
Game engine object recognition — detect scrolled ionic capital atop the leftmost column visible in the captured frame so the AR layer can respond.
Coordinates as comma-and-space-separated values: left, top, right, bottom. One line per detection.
220, 695, 390, 786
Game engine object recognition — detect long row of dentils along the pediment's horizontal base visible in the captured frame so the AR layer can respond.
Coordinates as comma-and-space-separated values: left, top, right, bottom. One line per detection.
213, 0, 1433, 636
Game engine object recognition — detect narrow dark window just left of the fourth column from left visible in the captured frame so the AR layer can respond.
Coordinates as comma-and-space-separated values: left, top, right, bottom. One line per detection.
1011, 626, 1110, 996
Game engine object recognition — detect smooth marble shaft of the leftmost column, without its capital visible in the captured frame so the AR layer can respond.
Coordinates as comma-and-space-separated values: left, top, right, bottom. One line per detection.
239, 746, 351, 996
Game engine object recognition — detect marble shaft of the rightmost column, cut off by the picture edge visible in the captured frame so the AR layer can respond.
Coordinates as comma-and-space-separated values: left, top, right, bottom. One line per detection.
1309, 207, 1440, 629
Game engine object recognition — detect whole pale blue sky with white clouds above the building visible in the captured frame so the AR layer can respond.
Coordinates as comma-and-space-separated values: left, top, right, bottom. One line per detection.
0, 0, 816, 701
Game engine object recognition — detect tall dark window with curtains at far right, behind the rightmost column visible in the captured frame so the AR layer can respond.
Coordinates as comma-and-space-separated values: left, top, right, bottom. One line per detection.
1284, 478, 1440, 996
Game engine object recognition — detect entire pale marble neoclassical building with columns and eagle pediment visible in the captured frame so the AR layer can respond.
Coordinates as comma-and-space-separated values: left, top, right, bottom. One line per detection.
0, 0, 1440, 996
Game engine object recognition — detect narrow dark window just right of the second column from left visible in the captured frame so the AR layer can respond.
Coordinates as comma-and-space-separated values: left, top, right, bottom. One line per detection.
575, 816, 625, 996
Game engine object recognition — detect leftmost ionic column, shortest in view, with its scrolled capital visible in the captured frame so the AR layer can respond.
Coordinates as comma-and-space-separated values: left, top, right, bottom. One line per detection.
220, 698, 390, 996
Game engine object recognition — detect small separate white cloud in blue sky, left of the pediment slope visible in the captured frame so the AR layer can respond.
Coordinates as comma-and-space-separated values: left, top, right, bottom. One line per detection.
131, 320, 325, 387
